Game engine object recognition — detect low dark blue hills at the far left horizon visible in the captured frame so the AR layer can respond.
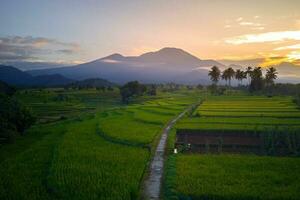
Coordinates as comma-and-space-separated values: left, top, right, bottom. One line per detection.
0, 65, 73, 87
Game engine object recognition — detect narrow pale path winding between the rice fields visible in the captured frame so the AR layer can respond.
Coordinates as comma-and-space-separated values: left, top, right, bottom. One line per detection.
144, 103, 200, 200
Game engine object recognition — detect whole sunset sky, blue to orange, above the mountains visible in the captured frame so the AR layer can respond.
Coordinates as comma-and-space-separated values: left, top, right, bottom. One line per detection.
0, 0, 300, 67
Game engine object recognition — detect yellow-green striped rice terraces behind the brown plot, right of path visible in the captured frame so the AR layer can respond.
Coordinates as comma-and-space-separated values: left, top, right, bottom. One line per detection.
177, 96, 300, 130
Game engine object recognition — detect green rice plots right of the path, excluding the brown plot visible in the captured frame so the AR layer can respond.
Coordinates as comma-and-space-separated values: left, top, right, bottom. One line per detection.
164, 95, 300, 200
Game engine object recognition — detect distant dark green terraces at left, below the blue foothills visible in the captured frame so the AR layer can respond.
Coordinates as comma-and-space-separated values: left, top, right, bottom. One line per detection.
17, 88, 121, 123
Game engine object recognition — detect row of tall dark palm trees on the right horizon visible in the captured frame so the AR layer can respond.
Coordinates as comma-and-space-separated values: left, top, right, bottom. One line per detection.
208, 66, 278, 91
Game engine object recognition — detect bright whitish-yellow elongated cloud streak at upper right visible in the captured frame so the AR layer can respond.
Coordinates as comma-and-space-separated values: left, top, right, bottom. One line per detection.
225, 31, 300, 45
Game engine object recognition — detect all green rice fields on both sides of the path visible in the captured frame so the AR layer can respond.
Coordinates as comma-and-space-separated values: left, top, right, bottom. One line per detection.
0, 84, 300, 200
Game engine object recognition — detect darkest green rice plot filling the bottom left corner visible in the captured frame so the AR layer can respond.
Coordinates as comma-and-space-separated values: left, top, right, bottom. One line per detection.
0, 122, 67, 200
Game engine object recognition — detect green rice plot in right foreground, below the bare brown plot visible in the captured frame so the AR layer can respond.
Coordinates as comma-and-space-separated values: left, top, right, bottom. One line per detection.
176, 155, 300, 199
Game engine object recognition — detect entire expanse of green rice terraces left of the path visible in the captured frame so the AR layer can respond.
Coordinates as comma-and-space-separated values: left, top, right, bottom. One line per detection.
0, 89, 199, 200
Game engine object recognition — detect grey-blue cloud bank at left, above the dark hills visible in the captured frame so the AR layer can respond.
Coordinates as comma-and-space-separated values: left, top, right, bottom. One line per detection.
0, 36, 80, 61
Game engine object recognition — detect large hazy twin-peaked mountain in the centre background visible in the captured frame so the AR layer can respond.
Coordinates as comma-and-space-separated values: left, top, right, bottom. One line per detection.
28, 47, 225, 83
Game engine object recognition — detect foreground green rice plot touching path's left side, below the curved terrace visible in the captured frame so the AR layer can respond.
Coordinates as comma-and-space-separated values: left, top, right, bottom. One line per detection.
48, 119, 149, 199
